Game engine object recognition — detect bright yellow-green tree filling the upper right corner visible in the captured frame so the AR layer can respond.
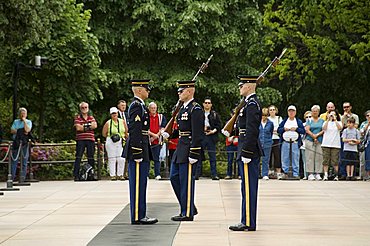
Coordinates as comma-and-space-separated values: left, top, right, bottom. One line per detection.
264, 0, 370, 117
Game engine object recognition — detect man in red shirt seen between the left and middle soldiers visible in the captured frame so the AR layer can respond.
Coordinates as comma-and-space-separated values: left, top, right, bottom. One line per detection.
148, 102, 167, 180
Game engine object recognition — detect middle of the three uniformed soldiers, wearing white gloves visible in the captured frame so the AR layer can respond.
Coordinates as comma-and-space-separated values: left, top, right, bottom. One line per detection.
170, 81, 204, 221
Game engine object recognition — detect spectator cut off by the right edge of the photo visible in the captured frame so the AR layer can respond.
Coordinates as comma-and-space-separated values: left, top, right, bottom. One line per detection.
360, 110, 370, 181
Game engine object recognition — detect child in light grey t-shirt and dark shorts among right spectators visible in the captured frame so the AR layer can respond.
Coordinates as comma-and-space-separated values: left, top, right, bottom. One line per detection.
342, 117, 360, 180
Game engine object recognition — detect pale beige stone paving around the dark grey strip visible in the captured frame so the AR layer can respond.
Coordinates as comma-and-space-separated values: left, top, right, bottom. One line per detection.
0, 179, 370, 246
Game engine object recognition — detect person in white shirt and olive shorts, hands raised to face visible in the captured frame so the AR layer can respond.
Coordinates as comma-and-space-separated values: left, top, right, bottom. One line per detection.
321, 111, 343, 181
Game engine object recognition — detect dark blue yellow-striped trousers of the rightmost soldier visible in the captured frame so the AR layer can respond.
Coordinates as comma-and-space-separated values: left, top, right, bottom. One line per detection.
240, 157, 260, 228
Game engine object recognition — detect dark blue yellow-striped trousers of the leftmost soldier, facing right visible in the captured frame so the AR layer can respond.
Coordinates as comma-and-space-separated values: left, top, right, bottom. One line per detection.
128, 160, 150, 222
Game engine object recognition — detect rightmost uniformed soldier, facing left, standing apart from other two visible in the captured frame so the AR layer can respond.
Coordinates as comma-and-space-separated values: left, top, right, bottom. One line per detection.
229, 75, 263, 231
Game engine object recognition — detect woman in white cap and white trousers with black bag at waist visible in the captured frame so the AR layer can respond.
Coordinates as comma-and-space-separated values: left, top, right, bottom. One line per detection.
102, 107, 126, 180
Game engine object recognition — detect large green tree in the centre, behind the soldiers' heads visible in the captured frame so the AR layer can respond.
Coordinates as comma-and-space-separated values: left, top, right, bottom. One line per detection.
81, 0, 280, 123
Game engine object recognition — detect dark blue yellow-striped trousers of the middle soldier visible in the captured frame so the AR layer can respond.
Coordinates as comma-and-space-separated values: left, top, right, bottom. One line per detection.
170, 163, 196, 217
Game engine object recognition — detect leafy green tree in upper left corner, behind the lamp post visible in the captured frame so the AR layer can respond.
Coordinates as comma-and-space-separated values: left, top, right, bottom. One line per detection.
0, 0, 105, 139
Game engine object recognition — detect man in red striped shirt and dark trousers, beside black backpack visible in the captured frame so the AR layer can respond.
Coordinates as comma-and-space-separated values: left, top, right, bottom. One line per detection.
73, 102, 98, 181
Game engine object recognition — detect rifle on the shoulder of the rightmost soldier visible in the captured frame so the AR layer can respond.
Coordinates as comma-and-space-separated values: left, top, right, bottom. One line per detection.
221, 48, 287, 137
